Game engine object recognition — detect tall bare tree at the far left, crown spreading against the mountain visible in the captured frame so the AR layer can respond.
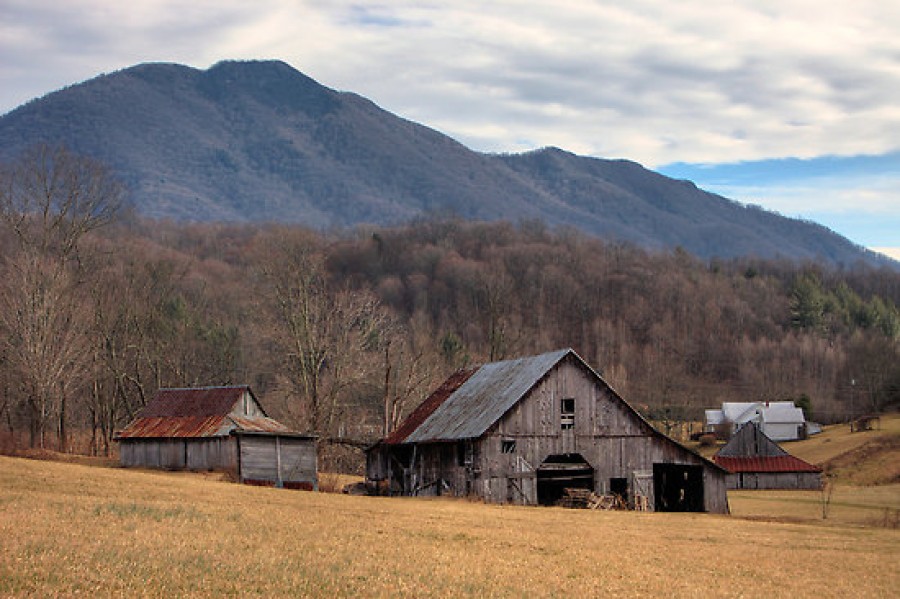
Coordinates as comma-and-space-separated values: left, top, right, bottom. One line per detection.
0, 146, 123, 449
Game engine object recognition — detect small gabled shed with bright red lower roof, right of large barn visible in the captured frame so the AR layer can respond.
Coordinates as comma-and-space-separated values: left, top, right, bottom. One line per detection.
713, 422, 822, 489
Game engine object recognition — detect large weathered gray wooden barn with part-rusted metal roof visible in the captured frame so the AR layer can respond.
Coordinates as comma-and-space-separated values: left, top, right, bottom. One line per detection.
366, 349, 728, 513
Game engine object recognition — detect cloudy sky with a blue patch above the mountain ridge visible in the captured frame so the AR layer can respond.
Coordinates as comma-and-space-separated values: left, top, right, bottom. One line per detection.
0, 0, 900, 256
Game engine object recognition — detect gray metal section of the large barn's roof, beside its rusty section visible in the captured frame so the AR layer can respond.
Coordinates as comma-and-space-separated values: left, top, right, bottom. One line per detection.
405, 349, 575, 443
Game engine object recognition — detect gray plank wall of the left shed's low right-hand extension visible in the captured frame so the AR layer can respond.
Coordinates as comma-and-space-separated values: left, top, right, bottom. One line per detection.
239, 435, 318, 490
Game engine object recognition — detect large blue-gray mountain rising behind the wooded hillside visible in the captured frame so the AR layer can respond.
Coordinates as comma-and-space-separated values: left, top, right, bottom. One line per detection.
0, 61, 879, 264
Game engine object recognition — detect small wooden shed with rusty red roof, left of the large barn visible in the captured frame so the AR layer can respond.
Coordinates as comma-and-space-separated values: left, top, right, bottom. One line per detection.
116, 386, 318, 490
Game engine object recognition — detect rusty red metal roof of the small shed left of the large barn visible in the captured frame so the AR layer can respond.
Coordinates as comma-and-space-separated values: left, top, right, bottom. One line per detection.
116, 385, 292, 439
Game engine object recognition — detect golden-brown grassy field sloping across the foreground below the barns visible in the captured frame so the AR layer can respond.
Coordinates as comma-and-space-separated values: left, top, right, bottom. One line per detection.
0, 457, 900, 597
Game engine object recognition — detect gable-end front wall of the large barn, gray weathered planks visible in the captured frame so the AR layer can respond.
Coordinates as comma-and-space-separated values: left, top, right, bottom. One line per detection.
478, 361, 728, 513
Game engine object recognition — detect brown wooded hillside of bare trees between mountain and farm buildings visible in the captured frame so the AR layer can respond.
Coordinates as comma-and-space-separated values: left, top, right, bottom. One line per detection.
0, 146, 900, 464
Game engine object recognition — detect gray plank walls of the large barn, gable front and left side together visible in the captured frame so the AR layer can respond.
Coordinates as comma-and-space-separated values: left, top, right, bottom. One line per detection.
380, 362, 728, 513
